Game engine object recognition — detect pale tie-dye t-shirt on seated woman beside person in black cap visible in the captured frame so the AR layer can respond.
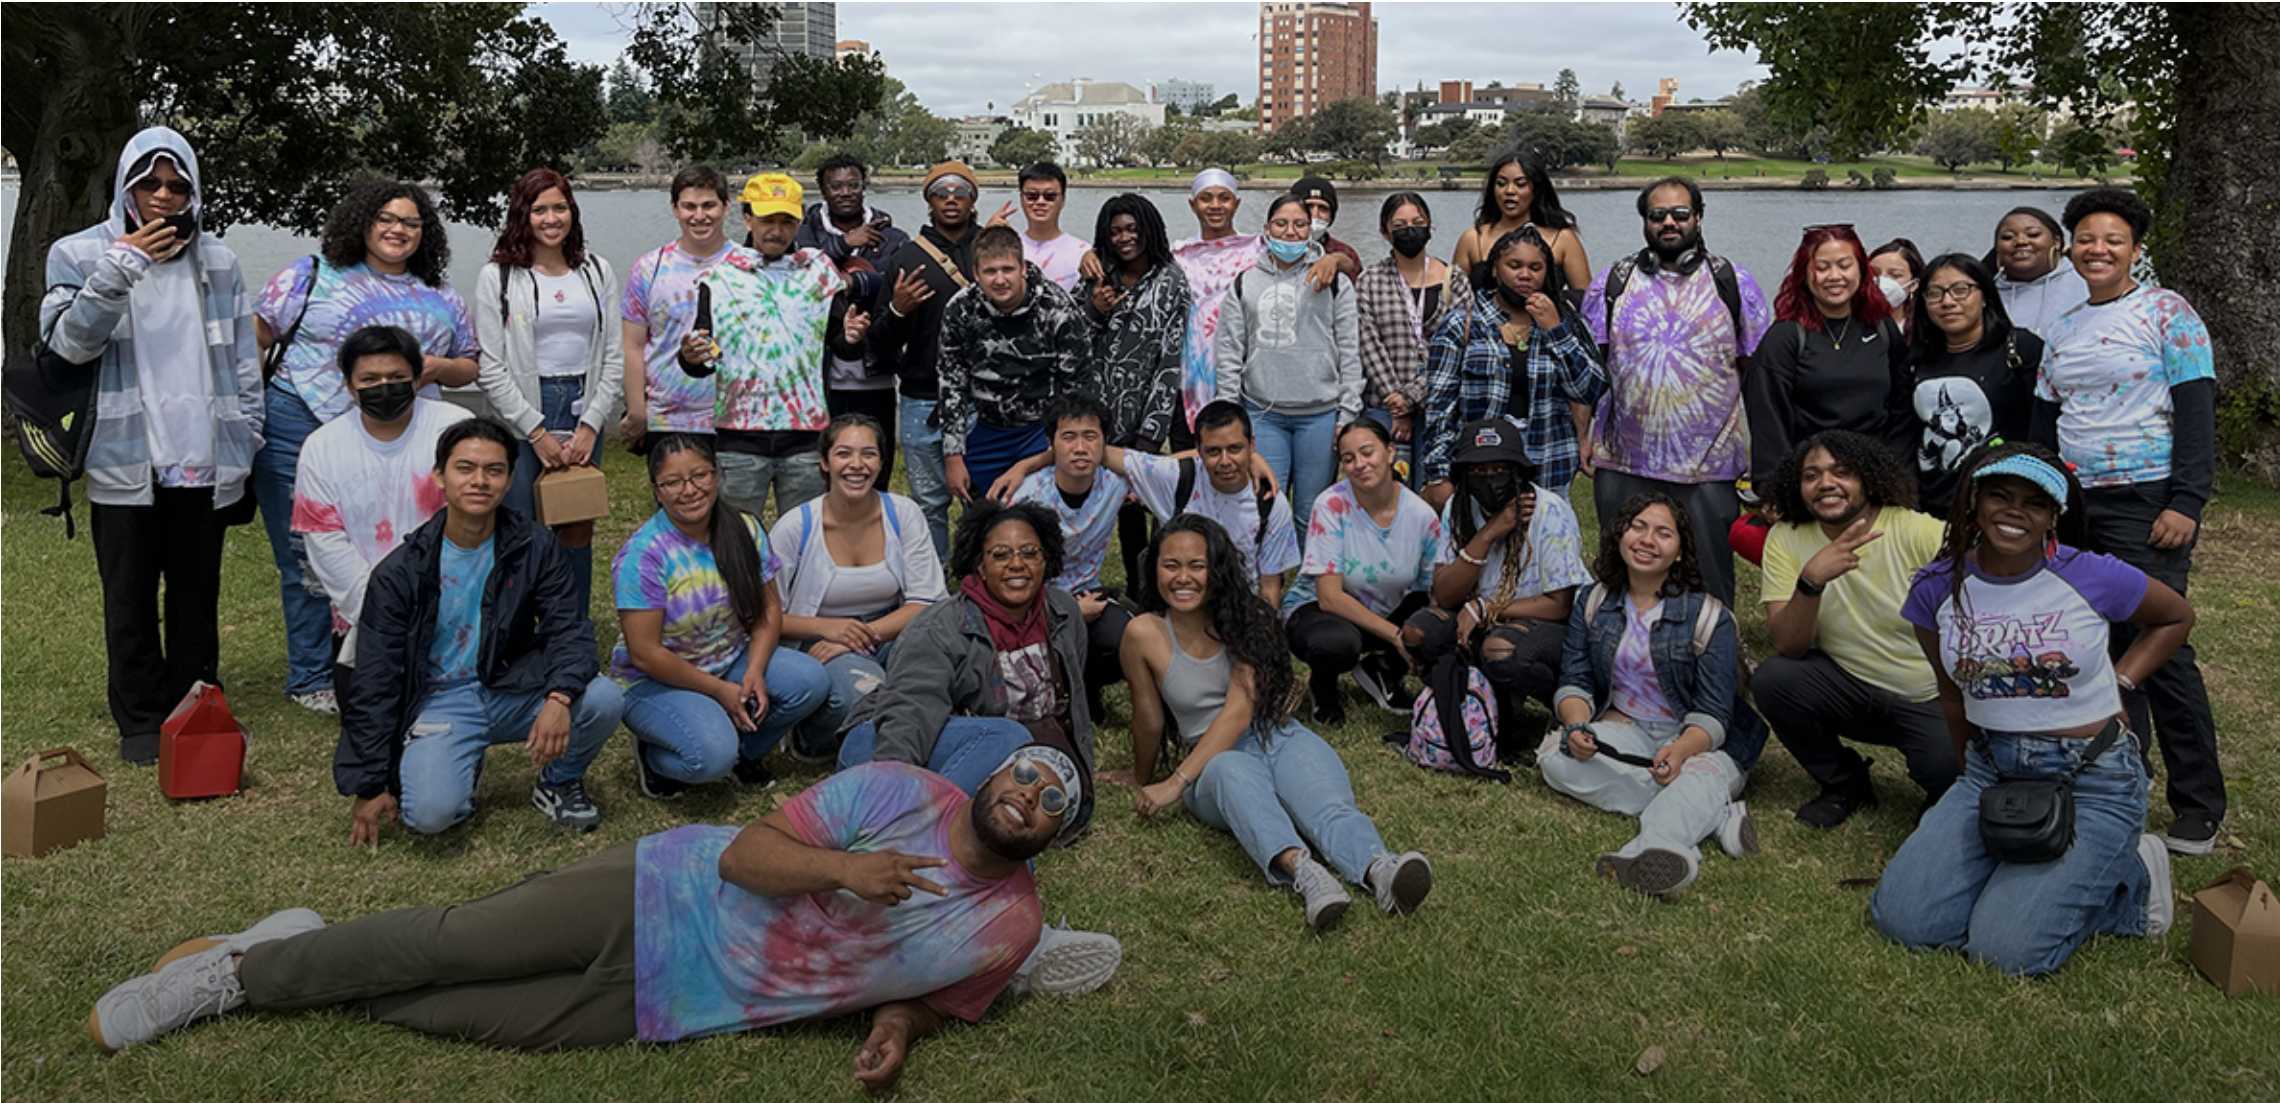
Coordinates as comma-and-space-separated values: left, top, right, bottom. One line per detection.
1284, 479, 1443, 618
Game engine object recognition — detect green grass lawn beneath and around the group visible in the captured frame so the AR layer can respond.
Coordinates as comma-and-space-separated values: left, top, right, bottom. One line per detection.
0, 451, 2280, 1103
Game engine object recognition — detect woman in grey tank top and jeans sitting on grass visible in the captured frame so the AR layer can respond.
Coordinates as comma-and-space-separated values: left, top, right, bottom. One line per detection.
1106, 513, 1432, 930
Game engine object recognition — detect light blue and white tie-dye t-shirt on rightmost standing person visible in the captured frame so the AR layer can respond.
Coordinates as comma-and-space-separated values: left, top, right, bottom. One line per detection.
2034, 287, 2216, 485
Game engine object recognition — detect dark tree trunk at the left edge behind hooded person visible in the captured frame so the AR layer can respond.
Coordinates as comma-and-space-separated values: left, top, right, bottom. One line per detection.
0, 5, 150, 356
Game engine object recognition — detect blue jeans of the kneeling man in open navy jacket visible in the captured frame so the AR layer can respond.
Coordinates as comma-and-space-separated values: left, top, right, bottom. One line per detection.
397, 677, 625, 834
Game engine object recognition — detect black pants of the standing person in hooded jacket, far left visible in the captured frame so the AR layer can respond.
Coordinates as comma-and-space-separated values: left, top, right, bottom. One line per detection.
89, 488, 224, 738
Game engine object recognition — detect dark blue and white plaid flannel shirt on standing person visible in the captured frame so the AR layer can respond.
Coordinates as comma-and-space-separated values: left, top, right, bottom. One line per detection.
1425, 292, 1607, 490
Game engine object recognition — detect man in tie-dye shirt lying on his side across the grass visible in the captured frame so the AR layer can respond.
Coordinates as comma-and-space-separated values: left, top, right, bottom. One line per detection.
87, 745, 1085, 1089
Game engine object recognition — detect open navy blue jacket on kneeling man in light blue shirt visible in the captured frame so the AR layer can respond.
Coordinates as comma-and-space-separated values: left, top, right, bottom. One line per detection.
333, 506, 602, 798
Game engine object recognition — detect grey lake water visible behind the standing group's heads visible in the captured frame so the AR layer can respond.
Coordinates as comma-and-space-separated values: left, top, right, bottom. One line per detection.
0, 185, 2070, 312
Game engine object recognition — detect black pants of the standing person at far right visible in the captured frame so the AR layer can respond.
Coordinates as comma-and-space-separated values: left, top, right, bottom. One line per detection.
2082, 481, 2225, 823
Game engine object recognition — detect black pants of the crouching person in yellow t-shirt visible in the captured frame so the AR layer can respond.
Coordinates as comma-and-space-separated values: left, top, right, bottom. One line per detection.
1749, 649, 1961, 804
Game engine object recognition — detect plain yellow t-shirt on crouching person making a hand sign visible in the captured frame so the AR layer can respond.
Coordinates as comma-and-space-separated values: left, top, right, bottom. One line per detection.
1760, 506, 1945, 702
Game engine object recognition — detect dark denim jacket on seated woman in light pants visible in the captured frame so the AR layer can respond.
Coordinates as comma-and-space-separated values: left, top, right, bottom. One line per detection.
1553, 583, 1765, 770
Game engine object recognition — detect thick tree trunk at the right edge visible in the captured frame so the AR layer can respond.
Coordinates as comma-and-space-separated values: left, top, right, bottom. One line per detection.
2161, 5, 2280, 394
